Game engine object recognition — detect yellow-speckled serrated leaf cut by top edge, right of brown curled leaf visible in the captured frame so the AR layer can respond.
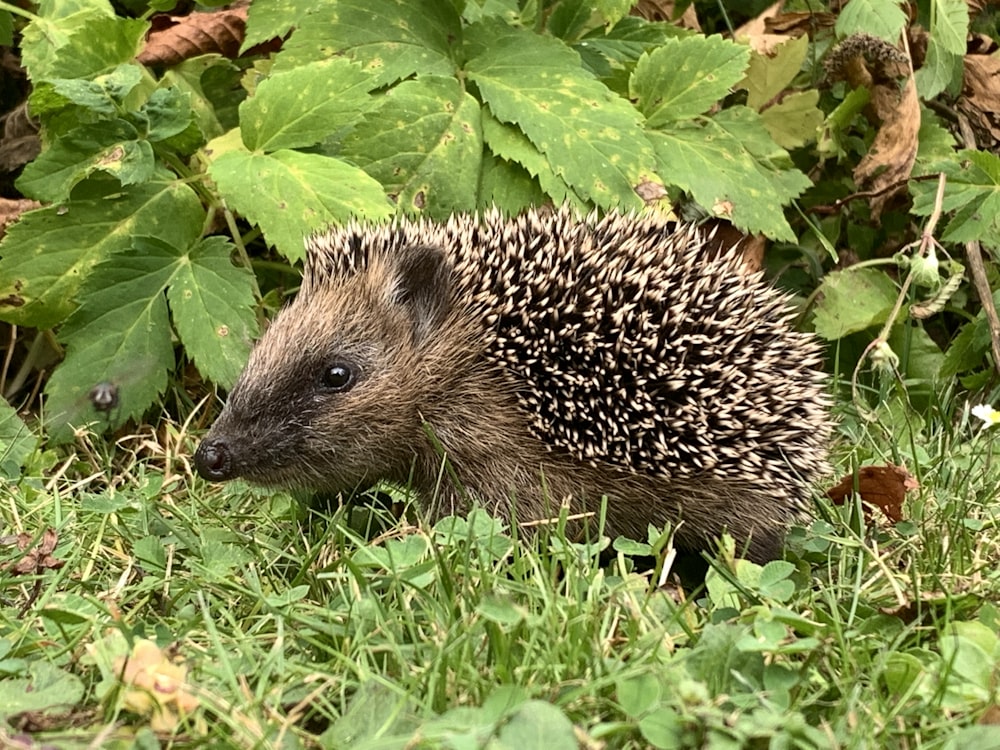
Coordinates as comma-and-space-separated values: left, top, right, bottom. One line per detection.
274, 0, 462, 88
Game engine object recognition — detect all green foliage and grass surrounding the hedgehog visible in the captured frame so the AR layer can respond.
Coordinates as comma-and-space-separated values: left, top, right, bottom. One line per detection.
0, 0, 1000, 749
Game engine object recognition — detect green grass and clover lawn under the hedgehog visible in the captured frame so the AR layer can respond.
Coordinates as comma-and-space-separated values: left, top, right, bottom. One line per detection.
0, 402, 1000, 750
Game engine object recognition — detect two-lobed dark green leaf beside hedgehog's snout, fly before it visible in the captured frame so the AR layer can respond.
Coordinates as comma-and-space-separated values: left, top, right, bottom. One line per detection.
45, 237, 257, 441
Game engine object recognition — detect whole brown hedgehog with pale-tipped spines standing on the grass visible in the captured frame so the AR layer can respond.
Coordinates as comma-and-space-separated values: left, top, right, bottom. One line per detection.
195, 207, 831, 562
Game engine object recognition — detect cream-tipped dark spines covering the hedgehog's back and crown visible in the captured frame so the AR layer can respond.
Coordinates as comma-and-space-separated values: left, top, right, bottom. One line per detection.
303, 207, 828, 520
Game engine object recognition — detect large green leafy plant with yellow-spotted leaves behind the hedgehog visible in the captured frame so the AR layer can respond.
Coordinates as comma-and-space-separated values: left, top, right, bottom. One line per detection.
0, 0, 821, 440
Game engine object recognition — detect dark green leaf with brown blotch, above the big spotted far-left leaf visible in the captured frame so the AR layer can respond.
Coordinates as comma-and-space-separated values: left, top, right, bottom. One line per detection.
17, 120, 156, 202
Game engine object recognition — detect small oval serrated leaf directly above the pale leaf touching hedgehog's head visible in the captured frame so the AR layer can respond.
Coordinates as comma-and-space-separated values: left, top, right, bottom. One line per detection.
240, 57, 376, 151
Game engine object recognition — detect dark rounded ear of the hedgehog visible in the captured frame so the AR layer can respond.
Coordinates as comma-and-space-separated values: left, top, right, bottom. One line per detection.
392, 245, 451, 341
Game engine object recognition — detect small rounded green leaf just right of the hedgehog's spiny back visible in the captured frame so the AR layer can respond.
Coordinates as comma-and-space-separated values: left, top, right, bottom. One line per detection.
815, 268, 897, 341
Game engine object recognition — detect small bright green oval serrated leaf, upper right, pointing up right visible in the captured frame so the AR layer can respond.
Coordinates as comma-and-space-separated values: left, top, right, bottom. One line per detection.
629, 36, 750, 128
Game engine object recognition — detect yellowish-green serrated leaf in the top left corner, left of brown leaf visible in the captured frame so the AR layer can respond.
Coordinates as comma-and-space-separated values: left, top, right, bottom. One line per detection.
22, 11, 149, 81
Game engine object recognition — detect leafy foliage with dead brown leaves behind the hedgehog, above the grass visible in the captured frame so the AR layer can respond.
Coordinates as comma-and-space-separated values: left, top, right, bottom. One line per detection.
0, 0, 1000, 452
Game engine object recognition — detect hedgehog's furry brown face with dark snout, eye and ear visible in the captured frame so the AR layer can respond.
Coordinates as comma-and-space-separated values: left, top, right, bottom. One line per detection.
195, 247, 451, 492
